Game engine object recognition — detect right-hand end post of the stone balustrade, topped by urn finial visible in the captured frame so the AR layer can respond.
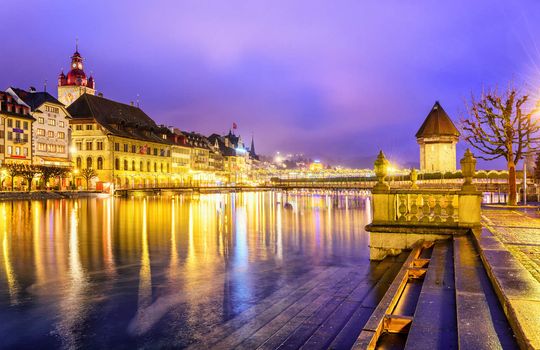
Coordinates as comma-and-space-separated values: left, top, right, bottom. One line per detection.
459, 149, 482, 229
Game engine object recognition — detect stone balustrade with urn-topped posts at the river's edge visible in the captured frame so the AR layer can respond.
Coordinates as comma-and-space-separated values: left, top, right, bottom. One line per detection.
366, 150, 482, 260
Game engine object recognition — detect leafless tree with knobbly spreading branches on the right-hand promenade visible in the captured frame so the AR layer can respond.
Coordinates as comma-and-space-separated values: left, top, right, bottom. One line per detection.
462, 87, 540, 205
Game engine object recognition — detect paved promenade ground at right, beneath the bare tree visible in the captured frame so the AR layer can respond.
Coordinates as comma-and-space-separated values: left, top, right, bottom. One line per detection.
482, 209, 540, 282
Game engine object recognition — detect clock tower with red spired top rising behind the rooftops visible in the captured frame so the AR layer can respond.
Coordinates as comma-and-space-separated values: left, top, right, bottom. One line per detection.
58, 45, 96, 107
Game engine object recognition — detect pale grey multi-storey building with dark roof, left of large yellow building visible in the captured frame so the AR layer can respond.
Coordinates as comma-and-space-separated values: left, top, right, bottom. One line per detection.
6, 88, 71, 167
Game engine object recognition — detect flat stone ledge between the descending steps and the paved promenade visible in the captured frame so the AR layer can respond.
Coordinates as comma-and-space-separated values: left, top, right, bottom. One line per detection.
473, 229, 540, 349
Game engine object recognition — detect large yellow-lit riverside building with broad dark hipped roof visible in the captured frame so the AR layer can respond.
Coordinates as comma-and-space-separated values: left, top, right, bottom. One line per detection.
68, 94, 174, 190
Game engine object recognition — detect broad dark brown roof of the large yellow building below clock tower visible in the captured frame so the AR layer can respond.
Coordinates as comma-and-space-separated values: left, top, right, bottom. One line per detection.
67, 93, 172, 144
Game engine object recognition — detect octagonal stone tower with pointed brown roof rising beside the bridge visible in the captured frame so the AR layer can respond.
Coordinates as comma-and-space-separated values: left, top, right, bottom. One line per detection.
416, 101, 459, 172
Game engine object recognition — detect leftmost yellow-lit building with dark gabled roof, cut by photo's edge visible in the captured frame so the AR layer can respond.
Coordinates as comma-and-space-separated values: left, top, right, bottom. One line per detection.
0, 91, 34, 164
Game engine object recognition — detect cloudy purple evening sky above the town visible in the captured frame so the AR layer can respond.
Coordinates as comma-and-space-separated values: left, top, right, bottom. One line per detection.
0, 0, 540, 167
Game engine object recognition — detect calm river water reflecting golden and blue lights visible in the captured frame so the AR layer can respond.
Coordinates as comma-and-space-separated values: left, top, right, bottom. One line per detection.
0, 192, 371, 349
